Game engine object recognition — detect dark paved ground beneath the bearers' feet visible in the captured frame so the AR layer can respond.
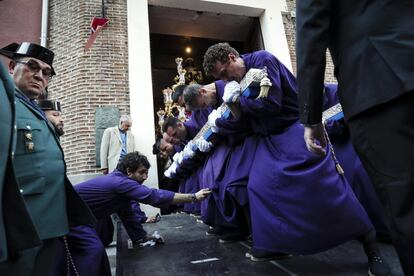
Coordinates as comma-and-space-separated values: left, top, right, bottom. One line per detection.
116, 214, 403, 276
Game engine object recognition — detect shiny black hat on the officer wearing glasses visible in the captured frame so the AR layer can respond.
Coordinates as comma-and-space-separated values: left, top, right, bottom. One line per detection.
0, 42, 56, 75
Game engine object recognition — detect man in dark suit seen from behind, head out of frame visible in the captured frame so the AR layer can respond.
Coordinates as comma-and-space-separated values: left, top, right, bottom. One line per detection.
296, 0, 414, 275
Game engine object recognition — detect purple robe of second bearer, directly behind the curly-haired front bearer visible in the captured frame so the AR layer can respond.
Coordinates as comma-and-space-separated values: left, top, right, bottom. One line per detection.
200, 81, 257, 235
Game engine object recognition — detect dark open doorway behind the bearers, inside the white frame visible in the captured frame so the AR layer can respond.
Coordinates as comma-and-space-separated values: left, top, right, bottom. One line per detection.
149, 6, 264, 203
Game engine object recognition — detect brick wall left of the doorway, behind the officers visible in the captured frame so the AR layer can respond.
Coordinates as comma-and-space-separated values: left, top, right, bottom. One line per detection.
48, 0, 129, 175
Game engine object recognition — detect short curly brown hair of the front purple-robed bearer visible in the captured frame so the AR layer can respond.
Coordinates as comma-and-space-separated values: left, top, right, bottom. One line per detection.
203, 42, 239, 76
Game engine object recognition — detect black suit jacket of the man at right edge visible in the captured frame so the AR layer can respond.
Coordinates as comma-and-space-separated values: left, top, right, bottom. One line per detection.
296, 0, 414, 124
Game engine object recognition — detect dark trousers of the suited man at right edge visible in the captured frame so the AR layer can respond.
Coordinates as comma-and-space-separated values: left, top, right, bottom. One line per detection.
348, 91, 414, 275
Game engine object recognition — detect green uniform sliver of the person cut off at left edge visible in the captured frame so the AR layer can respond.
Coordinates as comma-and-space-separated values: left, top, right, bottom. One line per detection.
0, 62, 41, 263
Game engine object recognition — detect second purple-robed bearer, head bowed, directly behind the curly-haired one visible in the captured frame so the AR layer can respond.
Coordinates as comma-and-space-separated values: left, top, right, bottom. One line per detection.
184, 81, 257, 243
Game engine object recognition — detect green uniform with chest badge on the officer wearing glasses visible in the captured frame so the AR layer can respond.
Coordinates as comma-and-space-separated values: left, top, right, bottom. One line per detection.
0, 65, 95, 276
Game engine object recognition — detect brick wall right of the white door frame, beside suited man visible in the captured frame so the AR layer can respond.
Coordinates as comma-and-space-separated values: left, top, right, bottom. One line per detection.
283, 0, 337, 83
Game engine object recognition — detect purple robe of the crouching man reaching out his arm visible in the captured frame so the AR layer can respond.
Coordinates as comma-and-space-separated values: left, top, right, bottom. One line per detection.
68, 170, 174, 276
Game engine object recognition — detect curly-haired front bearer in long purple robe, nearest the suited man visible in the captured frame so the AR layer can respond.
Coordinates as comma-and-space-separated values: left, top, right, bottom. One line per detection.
203, 43, 390, 275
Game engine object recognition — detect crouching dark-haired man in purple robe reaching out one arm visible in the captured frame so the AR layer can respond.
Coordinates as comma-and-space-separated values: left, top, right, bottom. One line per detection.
68, 152, 210, 276
